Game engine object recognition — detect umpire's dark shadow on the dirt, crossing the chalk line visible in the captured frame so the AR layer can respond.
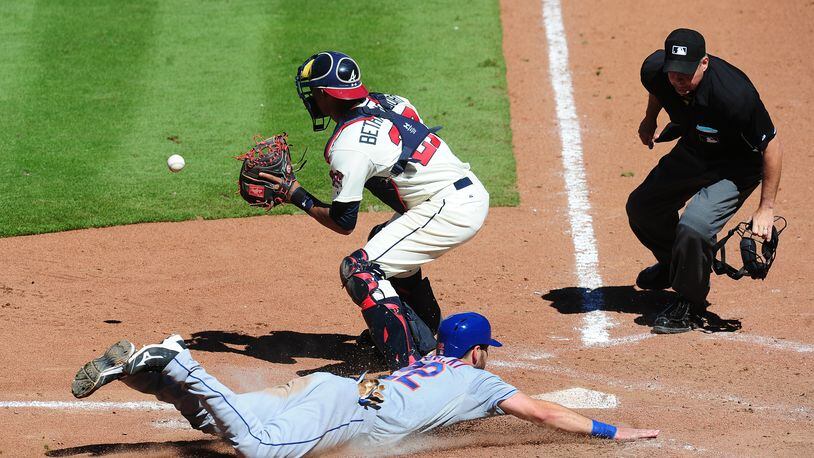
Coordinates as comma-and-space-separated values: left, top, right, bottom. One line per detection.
542, 286, 741, 332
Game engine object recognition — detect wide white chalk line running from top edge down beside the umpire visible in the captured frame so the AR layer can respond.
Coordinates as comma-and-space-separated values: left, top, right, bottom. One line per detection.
543, 0, 613, 346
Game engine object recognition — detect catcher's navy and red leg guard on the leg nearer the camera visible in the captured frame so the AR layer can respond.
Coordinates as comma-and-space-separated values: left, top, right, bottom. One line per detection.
339, 250, 421, 370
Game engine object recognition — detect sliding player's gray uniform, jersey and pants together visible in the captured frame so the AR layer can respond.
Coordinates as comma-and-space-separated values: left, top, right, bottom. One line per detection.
131, 350, 517, 456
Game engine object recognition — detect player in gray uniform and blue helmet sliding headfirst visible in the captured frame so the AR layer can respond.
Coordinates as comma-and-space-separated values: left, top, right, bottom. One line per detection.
72, 312, 659, 457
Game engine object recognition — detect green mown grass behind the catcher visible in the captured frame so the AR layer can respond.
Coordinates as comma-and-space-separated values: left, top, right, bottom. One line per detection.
0, 0, 518, 236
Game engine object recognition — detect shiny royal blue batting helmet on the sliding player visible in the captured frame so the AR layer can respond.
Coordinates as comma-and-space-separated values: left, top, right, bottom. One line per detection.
436, 312, 503, 358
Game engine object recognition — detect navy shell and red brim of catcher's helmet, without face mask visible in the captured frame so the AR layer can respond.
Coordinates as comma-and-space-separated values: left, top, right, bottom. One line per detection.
297, 51, 368, 100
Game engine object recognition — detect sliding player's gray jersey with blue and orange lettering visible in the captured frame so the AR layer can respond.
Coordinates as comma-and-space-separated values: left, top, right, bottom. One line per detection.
370, 356, 517, 443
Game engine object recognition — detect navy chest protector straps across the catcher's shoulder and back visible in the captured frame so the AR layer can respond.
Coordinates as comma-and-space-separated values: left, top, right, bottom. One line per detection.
334, 93, 441, 176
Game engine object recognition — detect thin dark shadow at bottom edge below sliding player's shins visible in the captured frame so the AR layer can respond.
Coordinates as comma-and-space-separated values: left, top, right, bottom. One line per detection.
45, 440, 228, 458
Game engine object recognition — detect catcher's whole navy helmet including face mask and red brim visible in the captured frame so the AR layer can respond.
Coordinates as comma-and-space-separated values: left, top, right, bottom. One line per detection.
294, 51, 368, 131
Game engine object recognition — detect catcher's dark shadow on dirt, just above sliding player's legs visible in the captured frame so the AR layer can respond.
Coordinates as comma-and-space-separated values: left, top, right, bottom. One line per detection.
187, 331, 387, 376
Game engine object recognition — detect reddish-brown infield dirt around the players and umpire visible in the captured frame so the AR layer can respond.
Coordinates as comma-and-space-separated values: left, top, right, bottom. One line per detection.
0, 0, 814, 456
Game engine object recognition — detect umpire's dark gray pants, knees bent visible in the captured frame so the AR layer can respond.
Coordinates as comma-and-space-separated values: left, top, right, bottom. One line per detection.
626, 141, 762, 307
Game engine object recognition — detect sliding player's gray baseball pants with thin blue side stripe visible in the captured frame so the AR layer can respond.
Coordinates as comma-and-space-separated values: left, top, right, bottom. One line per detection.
122, 350, 375, 457
